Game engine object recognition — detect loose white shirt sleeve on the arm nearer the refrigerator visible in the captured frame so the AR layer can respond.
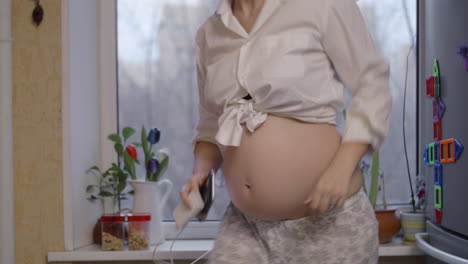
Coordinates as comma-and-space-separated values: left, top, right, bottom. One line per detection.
322, 0, 392, 151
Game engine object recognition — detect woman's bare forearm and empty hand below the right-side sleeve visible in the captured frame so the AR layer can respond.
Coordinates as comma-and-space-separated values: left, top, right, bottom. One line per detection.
304, 142, 369, 213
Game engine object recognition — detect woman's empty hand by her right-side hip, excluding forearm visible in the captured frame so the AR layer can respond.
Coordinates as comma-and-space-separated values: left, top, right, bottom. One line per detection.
304, 163, 352, 213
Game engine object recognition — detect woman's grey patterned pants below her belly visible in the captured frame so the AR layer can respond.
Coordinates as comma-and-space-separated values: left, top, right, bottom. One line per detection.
209, 190, 379, 264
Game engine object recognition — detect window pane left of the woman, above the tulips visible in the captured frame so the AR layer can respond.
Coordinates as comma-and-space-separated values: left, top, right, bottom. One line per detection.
117, 0, 229, 220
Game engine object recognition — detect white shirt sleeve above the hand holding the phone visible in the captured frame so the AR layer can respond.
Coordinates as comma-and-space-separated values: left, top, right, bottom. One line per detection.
192, 30, 219, 152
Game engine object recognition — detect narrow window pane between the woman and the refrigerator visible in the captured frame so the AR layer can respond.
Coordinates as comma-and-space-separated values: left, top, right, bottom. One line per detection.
358, 0, 416, 203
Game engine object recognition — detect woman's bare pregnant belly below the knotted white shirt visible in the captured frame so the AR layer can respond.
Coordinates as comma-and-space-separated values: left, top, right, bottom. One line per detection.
223, 114, 362, 220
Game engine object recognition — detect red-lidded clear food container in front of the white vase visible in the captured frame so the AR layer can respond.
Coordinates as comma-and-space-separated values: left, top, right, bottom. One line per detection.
127, 214, 151, 250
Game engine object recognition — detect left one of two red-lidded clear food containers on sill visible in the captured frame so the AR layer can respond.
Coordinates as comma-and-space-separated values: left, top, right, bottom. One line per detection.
101, 215, 125, 250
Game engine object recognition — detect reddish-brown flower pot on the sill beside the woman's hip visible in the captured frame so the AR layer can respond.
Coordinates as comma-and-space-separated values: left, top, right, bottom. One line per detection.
375, 209, 401, 244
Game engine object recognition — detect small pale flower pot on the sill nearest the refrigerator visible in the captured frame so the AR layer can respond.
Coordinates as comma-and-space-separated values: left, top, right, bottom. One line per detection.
398, 209, 426, 242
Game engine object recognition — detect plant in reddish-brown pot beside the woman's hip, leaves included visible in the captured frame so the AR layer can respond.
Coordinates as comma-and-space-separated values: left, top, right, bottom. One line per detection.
361, 151, 401, 244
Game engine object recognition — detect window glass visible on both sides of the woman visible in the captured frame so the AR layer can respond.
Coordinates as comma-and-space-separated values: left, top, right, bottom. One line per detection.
117, 0, 416, 226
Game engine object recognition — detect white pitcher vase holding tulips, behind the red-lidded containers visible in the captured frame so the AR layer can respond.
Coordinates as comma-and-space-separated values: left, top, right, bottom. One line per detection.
128, 179, 172, 245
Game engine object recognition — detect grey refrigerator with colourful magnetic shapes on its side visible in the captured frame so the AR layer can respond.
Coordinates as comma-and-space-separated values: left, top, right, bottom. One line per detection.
416, 0, 468, 264
